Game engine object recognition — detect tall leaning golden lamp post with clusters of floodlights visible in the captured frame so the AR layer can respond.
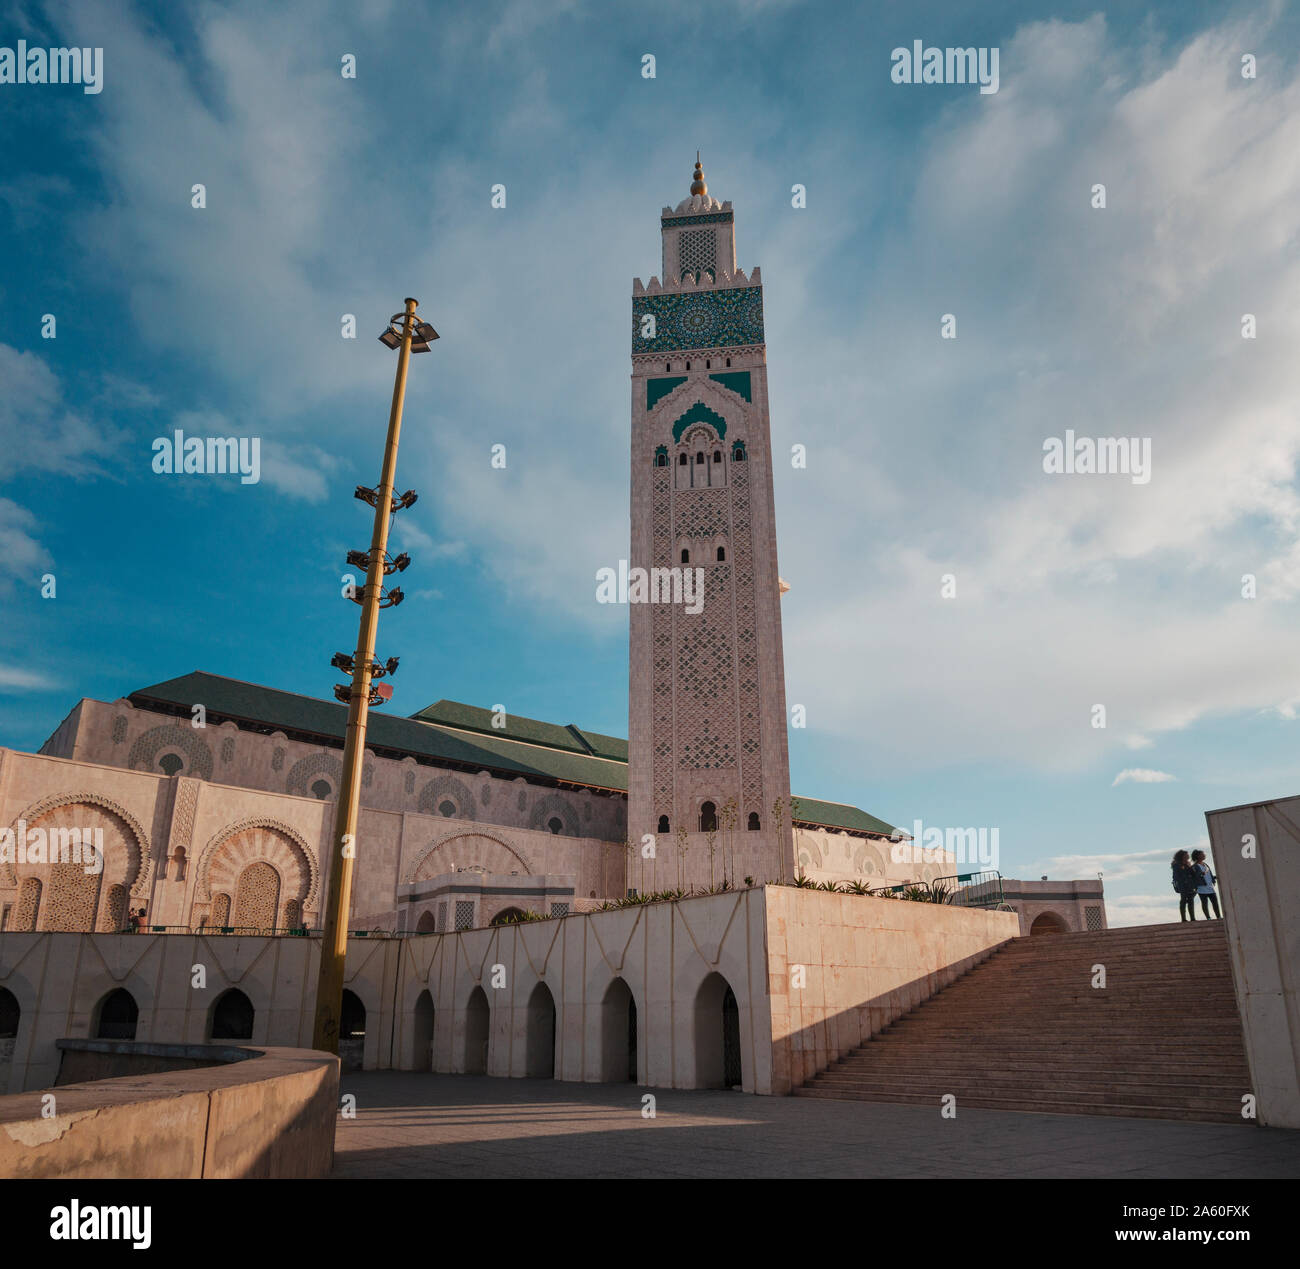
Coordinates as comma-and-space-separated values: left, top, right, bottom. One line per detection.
312, 298, 438, 1053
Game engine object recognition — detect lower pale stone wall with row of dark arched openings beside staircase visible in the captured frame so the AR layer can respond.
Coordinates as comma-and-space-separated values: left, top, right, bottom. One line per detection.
0, 887, 1017, 1110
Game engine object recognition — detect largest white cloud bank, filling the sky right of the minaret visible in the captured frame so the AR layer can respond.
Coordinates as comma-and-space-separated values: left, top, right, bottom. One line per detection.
763, 17, 1300, 776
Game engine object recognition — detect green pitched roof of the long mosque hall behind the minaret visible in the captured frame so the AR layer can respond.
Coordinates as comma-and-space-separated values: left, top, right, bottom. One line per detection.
130, 670, 894, 837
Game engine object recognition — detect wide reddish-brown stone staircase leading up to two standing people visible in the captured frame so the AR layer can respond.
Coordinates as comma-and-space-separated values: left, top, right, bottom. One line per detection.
794, 921, 1251, 1123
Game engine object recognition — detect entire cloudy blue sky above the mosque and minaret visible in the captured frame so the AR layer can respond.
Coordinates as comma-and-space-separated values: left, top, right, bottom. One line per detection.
0, 0, 1300, 923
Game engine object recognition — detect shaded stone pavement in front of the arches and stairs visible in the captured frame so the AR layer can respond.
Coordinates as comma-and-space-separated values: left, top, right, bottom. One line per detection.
333, 1071, 1300, 1178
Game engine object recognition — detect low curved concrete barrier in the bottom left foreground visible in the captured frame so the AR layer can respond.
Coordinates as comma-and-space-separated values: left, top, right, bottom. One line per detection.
0, 1040, 338, 1179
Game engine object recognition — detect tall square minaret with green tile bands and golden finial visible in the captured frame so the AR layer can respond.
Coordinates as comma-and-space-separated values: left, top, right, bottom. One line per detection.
628, 155, 793, 892
